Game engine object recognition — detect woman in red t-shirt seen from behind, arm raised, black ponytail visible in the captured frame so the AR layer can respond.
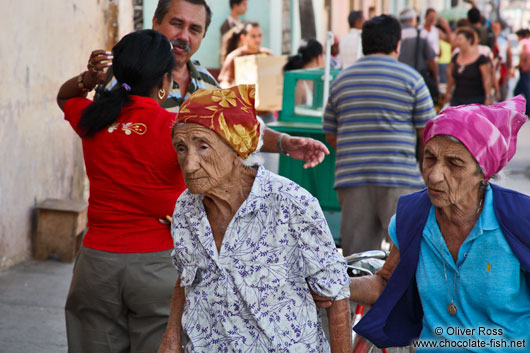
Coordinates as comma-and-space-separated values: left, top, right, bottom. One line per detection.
57, 30, 185, 352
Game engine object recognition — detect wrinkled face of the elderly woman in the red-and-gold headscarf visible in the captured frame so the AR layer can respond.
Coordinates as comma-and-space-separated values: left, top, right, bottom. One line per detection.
173, 123, 238, 194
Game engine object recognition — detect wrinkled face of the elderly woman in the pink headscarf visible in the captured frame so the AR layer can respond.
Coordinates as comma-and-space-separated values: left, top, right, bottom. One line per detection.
423, 136, 484, 207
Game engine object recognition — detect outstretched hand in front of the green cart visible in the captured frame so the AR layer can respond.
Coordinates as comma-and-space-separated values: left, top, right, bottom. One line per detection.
282, 135, 329, 168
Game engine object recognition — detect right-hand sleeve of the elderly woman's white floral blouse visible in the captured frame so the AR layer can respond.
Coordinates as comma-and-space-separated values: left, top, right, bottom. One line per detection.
290, 197, 350, 300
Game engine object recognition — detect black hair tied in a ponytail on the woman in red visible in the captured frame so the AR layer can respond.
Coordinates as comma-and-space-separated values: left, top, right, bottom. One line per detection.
78, 29, 176, 137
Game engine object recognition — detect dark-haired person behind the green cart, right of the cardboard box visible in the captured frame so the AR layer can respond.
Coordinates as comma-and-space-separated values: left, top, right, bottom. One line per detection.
283, 38, 324, 106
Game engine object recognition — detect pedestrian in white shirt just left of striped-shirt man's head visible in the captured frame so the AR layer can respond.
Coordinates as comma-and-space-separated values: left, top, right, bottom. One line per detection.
339, 11, 364, 69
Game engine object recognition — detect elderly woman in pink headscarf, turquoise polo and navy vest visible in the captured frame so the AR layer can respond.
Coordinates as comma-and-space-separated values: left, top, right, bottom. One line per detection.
318, 96, 530, 352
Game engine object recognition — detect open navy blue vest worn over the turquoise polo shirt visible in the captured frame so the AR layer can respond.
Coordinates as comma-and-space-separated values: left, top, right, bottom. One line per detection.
354, 184, 530, 348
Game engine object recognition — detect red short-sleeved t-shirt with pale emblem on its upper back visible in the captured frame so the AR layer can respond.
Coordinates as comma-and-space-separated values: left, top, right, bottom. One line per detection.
64, 96, 186, 253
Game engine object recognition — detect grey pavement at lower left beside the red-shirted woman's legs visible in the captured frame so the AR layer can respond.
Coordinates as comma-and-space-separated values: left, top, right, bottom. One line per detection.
0, 257, 73, 353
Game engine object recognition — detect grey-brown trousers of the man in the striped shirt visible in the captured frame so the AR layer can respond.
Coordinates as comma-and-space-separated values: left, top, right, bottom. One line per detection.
337, 185, 418, 256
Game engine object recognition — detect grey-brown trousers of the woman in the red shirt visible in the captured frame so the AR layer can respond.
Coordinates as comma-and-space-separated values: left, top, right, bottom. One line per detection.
65, 247, 177, 353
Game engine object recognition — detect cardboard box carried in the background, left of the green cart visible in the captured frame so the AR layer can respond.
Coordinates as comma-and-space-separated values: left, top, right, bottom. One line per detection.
234, 55, 287, 111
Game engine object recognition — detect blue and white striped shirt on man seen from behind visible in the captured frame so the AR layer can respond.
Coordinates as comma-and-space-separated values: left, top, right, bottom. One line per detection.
324, 55, 436, 188
